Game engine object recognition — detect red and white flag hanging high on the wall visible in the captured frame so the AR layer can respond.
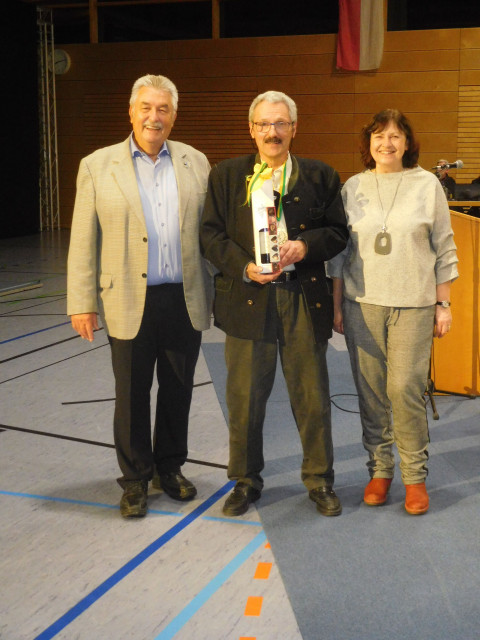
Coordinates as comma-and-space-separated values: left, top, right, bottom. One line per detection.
337, 0, 384, 71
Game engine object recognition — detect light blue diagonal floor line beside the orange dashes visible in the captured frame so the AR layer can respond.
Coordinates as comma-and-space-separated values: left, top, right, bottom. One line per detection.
155, 531, 267, 640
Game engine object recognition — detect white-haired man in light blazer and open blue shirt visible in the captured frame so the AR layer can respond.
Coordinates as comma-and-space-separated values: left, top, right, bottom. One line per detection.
67, 75, 213, 517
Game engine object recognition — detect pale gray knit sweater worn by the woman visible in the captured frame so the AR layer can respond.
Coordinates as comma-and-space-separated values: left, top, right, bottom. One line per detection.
328, 167, 458, 307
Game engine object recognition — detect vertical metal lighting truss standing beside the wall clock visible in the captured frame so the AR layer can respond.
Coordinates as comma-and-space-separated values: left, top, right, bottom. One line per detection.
37, 7, 60, 231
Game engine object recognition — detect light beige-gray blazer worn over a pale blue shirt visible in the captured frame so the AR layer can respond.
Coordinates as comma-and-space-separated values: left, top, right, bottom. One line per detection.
67, 138, 213, 340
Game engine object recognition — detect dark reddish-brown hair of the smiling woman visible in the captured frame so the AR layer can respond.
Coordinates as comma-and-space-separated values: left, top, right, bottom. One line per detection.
360, 109, 420, 169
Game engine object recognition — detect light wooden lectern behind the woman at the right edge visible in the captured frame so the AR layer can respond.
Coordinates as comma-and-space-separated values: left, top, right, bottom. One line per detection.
431, 211, 480, 396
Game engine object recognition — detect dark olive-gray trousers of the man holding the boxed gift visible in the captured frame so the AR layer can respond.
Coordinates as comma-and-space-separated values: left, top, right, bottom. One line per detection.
225, 281, 334, 490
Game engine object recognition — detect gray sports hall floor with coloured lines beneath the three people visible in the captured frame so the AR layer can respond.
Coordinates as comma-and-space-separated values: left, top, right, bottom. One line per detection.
0, 232, 480, 640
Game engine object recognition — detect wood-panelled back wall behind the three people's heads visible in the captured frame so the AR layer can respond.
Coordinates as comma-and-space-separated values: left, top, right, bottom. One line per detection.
57, 29, 480, 227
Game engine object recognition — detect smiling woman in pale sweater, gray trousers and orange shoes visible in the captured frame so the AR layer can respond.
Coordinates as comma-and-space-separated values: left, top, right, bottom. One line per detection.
329, 109, 458, 514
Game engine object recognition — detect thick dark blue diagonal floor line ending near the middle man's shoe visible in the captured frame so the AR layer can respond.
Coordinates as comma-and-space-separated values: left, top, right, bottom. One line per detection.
31, 481, 234, 640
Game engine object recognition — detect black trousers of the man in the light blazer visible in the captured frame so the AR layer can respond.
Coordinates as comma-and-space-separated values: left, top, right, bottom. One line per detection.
109, 284, 201, 480
